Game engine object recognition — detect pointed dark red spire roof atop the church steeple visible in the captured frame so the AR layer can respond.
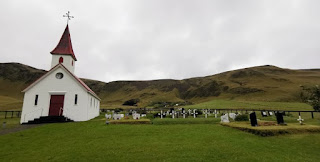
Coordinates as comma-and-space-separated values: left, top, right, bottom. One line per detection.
50, 25, 77, 61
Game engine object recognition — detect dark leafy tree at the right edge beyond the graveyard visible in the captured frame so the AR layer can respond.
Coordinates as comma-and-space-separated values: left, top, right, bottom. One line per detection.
300, 85, 320, 111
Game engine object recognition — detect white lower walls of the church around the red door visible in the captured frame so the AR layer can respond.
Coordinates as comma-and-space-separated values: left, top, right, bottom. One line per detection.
21, 68, 97, 123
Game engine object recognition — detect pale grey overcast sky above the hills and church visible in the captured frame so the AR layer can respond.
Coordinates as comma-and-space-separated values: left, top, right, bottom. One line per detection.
0, 0, 320, 82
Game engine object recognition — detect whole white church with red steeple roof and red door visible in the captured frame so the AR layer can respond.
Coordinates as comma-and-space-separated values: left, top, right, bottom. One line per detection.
20, 25, 100, 124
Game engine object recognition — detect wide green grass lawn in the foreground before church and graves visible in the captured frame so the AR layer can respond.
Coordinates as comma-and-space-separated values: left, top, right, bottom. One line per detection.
0, 117, 320, 161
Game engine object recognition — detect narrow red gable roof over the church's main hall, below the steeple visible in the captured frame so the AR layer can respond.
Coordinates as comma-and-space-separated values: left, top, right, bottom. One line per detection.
22, 64, 101, 100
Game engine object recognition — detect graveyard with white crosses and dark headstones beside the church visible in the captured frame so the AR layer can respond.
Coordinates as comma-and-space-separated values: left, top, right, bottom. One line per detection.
99, 108, 320, 137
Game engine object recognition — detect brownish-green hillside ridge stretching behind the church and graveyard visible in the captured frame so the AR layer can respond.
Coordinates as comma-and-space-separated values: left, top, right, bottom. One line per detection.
0, 63, 320, 110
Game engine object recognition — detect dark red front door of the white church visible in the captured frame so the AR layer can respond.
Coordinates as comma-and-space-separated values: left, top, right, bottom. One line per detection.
49, 95, 64, 116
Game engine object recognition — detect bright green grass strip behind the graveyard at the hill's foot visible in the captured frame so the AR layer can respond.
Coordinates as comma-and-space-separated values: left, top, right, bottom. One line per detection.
185, 100, 313, 110
